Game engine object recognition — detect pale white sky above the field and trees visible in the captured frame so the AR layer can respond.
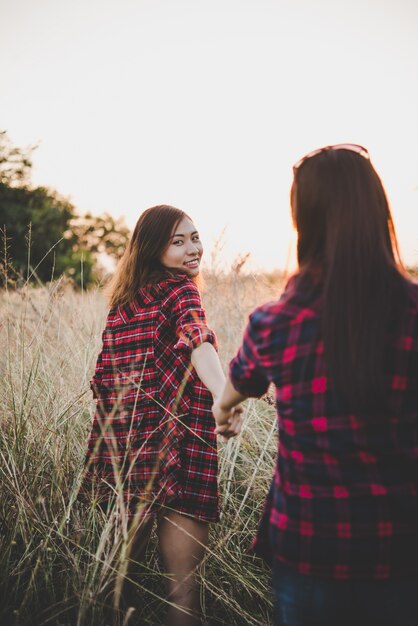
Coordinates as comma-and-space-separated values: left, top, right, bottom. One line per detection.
0, 0, 418, 268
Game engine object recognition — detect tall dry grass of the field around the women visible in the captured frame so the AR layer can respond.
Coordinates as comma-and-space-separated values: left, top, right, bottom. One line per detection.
0, 268, 281, 626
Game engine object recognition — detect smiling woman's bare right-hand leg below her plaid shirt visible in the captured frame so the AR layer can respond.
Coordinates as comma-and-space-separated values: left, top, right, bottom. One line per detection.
158, 511, 209, 626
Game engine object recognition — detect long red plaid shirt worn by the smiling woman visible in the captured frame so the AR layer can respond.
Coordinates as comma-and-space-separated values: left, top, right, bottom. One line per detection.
85, 275, 219, 521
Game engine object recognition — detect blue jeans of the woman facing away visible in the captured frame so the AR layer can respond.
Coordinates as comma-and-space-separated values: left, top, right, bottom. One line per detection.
273, 561, 418, 626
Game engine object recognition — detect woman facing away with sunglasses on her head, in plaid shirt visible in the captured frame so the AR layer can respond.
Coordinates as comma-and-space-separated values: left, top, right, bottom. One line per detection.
214, 144, 418, 626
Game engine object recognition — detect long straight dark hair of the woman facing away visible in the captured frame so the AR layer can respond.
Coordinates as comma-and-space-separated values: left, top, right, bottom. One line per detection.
291, 149, 406, 410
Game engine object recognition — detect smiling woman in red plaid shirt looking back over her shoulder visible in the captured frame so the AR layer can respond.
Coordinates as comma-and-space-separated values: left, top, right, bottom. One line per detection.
85, 205, 242, 626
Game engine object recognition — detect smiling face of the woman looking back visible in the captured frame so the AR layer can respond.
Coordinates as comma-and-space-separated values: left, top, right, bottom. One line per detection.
160, 217, 203, 276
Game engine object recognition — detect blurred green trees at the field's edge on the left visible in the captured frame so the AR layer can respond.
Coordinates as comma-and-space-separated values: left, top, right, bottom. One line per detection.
0, 131, 129, 286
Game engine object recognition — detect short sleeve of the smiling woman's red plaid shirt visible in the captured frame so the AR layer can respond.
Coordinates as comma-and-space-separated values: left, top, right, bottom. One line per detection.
171, 281, 217, 352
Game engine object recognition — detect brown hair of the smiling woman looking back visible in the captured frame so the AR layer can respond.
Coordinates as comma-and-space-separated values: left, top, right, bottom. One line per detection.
106, 204, 189, 308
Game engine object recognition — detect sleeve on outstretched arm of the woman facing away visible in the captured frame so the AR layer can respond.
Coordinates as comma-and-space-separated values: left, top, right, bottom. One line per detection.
229, 311, 270, 398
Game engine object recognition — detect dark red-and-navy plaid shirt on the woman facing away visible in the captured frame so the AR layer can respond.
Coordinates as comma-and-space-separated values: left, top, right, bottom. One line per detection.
230, 279, 418, 579
